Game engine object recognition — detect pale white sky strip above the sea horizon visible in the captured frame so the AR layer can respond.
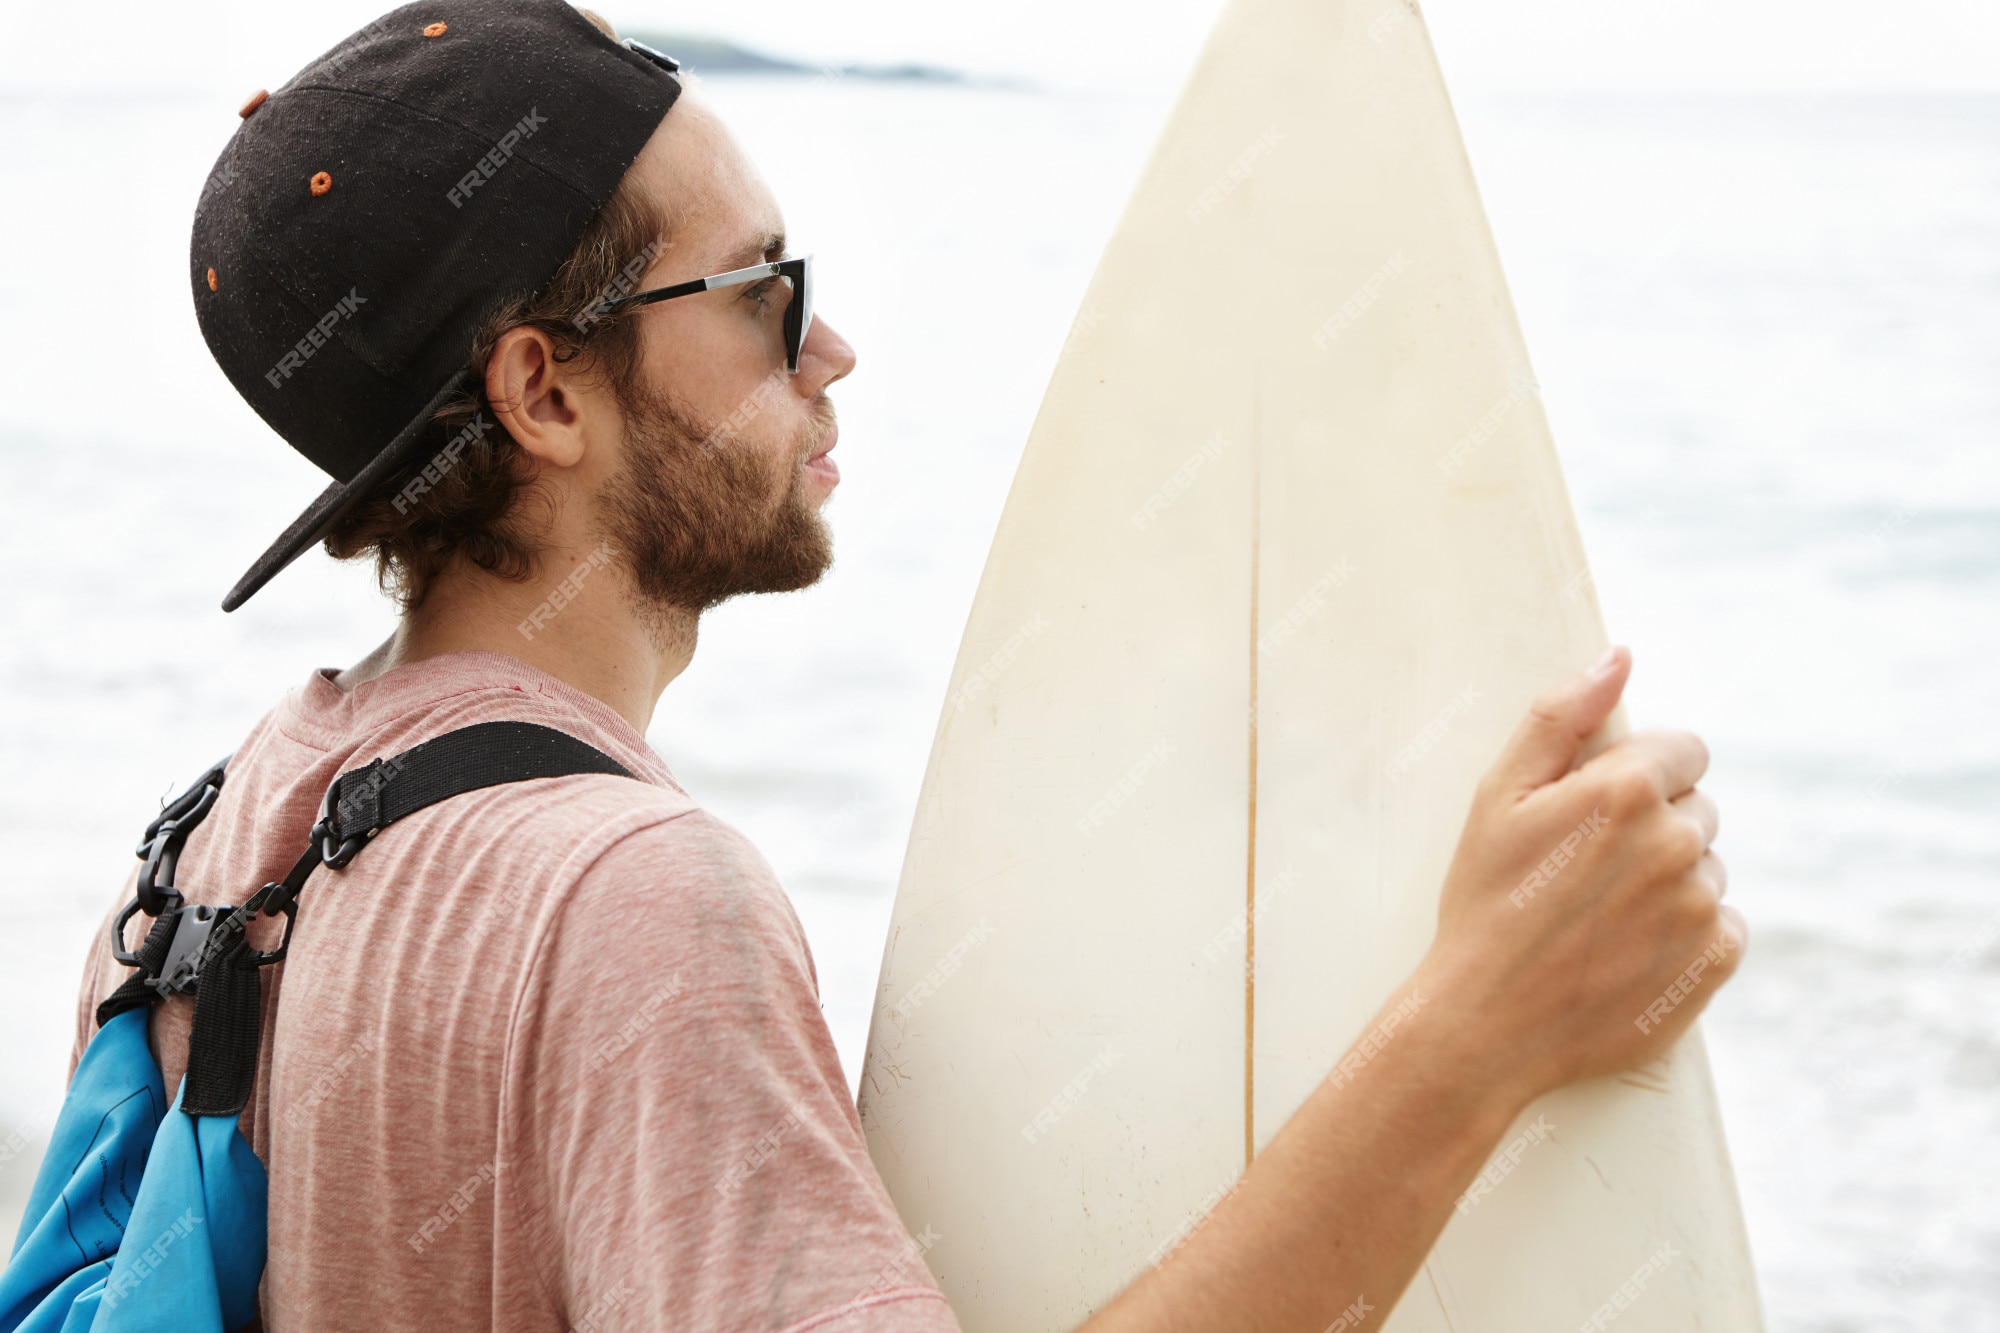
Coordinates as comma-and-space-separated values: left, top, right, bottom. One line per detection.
0, 0, 2000, 96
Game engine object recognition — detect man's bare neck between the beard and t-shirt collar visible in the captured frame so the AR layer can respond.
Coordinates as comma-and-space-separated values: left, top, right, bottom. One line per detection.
336, 546, 700, 735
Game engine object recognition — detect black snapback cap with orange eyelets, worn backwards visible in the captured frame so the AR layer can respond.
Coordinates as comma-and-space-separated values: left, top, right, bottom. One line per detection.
188, 0, 680, 610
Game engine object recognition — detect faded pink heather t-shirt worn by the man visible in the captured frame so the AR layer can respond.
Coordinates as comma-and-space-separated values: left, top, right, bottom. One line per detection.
76, 652, 958, 1333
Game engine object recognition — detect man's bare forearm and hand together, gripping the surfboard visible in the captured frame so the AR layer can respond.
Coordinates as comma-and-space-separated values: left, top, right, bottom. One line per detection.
1084, 648, 1744, 1333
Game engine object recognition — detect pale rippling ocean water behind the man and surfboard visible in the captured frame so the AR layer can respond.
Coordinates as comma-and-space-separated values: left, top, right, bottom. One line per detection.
0, 70, 2000, 1333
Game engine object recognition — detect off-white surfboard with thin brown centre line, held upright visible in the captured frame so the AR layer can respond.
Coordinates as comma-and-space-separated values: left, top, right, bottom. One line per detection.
860, 0, 1760, 1333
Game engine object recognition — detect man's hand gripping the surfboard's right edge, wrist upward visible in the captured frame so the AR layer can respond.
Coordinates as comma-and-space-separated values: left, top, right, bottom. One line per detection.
1418, 648, 1744, 1101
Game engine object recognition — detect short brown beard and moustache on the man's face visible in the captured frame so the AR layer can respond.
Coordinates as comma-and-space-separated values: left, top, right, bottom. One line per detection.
598, 368, 834, 610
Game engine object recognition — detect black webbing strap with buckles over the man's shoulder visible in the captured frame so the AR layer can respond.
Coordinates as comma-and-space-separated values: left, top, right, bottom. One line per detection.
98, 723, 632, 1115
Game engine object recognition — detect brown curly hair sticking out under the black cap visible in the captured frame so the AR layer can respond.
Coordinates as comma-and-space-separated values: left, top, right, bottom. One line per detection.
326, 10, 670, 610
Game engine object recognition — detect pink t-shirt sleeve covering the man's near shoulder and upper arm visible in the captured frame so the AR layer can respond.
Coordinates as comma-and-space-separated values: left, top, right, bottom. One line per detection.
502, 811, 958, 1333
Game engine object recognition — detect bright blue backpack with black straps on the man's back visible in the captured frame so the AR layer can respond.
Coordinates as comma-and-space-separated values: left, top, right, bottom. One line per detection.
0, 723, 632, 1333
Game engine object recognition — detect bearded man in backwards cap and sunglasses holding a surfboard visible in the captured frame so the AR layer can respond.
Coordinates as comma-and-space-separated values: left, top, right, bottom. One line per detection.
78, 0, 1744, 1333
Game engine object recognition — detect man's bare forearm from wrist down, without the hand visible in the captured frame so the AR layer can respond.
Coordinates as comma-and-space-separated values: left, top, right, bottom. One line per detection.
1082, 973, 1526, 1333
